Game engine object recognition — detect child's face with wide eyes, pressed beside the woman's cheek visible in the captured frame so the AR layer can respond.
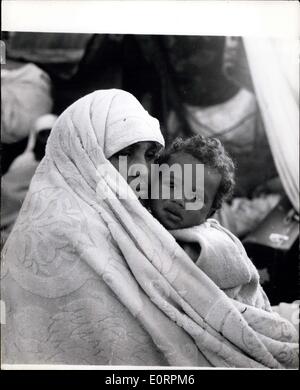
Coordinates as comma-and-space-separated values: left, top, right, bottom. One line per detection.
151, 152, 221, 230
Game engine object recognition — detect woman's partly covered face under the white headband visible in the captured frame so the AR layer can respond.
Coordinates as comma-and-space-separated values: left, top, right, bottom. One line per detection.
109, 141, 162, 204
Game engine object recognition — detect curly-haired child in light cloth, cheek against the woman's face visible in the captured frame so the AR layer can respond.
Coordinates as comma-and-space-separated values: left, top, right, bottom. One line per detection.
150, 135, 270, 310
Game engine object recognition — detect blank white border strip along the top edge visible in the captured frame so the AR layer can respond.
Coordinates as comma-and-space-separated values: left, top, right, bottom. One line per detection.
2, 0, 300, 37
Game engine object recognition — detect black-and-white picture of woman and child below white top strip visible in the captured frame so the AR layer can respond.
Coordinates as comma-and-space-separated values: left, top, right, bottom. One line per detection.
1, 1, 300, 372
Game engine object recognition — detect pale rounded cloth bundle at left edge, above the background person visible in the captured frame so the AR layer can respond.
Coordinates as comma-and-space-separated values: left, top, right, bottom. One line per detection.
1, 61, 53, 175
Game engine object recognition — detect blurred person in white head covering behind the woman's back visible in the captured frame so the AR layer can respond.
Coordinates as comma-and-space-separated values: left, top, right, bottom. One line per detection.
1, 114, 57, 245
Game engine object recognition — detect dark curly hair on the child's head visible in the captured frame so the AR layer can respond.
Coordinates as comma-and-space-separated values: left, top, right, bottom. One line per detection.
157, 135, 235, 215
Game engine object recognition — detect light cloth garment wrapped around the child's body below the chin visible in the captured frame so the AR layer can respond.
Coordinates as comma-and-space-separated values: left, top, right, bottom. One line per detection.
170, 218, 271, 311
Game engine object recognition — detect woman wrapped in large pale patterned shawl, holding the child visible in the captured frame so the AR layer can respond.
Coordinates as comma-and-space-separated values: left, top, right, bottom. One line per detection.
2, 90, 298, 368
